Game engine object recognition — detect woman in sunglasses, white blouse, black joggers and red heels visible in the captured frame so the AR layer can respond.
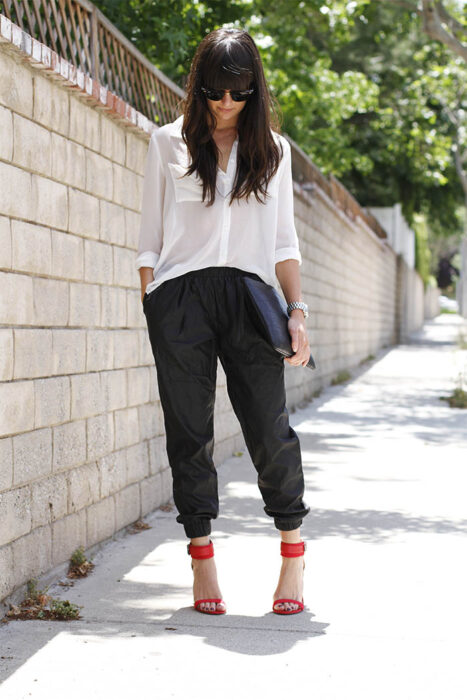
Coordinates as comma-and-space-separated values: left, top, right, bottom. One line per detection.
137, 29, 310, 614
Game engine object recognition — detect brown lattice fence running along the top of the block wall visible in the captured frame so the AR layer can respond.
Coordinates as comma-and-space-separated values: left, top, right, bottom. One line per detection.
0, 0, 387, 238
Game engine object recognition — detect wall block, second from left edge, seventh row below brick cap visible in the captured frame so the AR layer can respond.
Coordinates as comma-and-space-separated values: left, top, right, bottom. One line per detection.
34, 377, 70, 428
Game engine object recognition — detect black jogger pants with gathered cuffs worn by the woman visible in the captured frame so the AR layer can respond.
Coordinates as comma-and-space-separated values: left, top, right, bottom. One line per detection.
143, 266, 310, 538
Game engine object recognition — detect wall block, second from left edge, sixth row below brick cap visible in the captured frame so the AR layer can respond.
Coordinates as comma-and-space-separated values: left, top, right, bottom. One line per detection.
13, 328, 52, 379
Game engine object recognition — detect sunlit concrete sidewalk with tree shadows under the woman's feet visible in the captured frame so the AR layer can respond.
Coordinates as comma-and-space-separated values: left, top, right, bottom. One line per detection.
0, 314, 467, 700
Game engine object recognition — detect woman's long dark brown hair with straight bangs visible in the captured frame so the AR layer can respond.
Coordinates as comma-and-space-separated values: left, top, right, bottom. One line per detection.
181, 29, 283, 206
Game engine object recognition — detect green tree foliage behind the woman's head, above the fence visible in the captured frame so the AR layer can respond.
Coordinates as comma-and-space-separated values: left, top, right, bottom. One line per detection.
92, 0, 467, 235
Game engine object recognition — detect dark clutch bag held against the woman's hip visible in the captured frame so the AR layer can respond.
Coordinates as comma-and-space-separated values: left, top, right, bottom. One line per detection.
243, 276, 316, 369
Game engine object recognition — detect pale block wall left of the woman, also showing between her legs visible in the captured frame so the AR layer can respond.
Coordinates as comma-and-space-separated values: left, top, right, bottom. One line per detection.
0, 34, 243, 601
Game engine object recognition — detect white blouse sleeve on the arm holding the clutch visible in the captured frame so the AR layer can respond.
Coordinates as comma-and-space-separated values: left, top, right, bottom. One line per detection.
275, 138, 302, 265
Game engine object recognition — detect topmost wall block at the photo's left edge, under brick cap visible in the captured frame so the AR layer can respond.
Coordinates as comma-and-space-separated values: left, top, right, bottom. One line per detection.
0, 51, 33, 117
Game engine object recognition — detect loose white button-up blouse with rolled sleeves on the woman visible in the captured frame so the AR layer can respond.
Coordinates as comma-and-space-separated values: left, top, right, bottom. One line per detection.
136, 115, 302, 294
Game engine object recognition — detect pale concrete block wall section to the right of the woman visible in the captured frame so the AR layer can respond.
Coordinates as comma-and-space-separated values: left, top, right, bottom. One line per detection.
286, 183, 397, 406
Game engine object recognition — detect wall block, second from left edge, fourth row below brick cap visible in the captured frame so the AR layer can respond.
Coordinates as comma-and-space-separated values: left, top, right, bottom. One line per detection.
11, 219, 52, 275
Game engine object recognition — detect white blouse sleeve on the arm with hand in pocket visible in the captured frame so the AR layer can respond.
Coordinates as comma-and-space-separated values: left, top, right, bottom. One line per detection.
136, 130, 165, 269
